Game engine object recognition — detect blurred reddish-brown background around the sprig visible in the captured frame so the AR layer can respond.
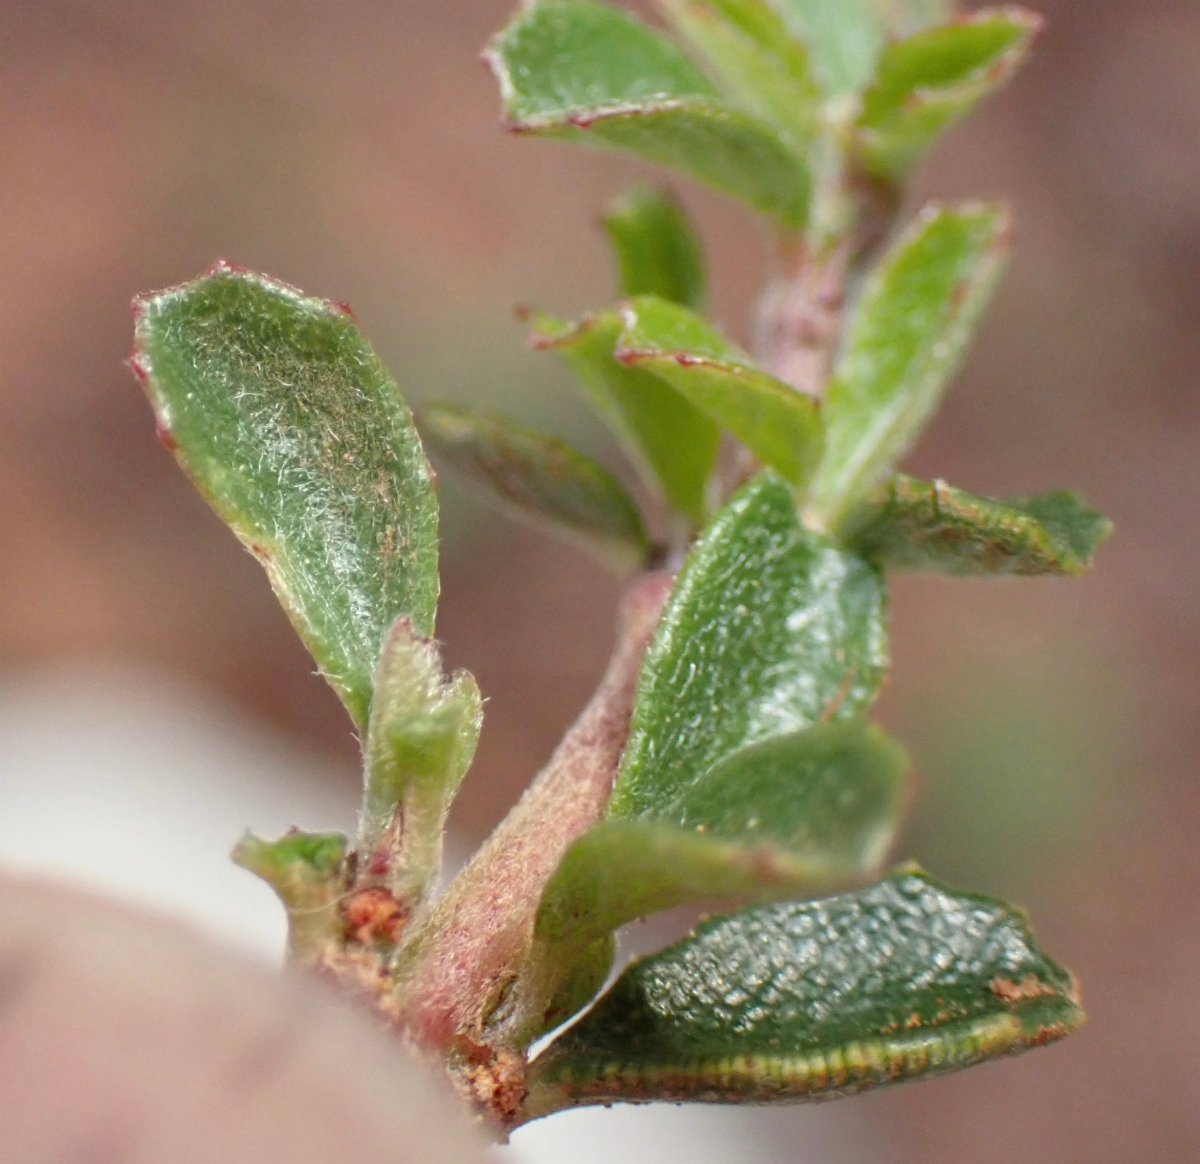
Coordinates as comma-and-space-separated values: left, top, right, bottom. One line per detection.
0, 0, 1200, 1164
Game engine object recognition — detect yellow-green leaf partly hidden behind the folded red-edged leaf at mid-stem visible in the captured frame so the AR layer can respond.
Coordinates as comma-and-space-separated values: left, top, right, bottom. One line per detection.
533, 312, 720, 524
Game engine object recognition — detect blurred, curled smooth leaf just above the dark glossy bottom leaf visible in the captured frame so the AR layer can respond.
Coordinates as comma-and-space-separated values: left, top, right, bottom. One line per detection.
536, 719, 908, 958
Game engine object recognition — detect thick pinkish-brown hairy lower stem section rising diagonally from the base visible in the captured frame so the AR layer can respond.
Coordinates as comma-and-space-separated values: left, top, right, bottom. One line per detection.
398, 572, 671, 1052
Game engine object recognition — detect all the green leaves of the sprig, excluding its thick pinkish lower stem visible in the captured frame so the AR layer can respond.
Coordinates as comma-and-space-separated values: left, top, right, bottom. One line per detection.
133, 0, 1110, 1126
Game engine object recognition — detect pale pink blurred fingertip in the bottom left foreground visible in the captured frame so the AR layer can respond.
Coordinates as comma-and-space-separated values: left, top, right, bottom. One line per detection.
0, 876, 482, 1164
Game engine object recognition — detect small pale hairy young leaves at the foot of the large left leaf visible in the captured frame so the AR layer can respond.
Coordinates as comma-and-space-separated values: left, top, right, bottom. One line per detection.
358, 618, 484, 902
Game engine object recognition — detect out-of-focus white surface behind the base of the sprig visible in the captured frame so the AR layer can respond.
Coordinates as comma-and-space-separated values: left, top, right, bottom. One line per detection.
0, 668, 862, 1164
